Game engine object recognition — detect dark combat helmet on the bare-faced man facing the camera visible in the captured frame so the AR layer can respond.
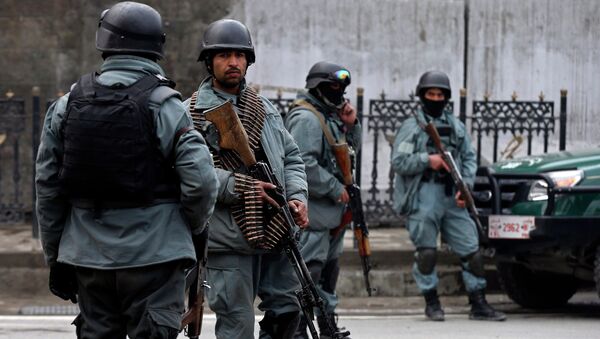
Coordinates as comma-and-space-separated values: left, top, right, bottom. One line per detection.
198, 19, 255, 68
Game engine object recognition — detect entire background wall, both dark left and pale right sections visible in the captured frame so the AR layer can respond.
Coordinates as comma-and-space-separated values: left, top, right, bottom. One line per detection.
0, 0, 600, 215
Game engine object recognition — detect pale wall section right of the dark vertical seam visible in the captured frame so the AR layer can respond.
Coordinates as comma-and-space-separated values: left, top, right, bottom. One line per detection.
468, 0, 600, 153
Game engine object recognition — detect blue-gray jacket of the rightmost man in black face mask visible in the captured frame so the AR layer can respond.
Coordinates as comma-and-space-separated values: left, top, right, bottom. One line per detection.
392, 110, 477, 215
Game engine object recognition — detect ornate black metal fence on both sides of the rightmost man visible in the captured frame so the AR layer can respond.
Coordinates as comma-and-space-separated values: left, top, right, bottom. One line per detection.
357, 90, 567, 225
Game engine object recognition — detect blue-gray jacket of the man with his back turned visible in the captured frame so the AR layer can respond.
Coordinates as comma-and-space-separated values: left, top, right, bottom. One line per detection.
35, 55, 218, 269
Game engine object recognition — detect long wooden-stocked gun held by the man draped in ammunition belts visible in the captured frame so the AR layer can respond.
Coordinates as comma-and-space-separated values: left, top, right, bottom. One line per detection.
204, 101, 350, 339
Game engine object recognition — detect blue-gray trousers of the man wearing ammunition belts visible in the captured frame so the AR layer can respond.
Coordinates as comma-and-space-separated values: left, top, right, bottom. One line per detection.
207, 252, 300, 339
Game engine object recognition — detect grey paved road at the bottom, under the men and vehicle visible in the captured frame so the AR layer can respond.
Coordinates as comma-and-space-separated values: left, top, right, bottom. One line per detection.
0, 291, 600, 339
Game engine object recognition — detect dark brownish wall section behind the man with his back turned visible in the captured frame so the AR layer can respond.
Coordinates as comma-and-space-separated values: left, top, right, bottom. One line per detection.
0, 0, 243, 215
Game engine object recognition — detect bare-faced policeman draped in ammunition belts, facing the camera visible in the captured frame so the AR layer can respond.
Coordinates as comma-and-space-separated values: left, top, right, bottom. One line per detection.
187, 19, 308, 339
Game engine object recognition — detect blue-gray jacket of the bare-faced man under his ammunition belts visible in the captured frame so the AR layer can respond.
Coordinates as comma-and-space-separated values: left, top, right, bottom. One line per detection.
184, 77, 308, 254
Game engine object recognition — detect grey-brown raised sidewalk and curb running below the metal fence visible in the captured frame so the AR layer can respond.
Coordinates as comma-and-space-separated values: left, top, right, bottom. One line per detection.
0, 225, 510, 315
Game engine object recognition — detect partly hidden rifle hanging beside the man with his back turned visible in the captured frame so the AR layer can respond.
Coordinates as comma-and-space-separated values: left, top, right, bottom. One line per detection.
181, 226, 210, 339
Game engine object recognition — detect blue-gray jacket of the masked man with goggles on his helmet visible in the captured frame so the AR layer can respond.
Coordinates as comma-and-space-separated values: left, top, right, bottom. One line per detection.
285, 91, 362, 231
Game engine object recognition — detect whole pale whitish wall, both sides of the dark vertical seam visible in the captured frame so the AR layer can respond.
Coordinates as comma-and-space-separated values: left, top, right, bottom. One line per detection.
240, 0, 600, 183
